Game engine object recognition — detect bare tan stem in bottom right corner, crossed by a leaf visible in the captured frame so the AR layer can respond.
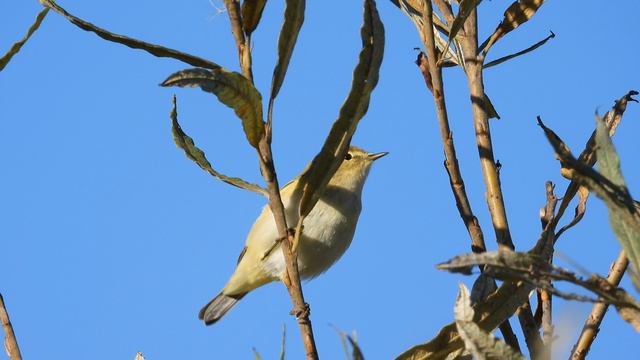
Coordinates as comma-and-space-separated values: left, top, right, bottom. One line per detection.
570, 251, 629, 360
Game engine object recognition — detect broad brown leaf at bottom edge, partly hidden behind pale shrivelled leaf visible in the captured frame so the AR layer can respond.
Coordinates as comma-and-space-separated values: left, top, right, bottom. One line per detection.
396, 282, 533, 360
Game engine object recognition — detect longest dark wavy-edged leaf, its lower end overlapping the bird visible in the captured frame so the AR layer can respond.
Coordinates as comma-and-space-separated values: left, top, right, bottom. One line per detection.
299, 0, 384, 217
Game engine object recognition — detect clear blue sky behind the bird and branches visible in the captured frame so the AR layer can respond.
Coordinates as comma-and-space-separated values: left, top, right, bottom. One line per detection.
0, 0, 640, 360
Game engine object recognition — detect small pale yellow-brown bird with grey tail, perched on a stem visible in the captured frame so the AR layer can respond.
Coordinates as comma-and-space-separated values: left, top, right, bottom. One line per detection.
198, 146, 388, 325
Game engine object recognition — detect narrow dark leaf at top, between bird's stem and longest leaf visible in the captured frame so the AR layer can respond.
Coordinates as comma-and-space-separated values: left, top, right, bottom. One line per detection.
269, 0, 306, 104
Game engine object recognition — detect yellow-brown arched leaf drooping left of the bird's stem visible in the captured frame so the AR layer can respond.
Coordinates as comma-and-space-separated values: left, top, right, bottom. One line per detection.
165, 69, 264, 148
